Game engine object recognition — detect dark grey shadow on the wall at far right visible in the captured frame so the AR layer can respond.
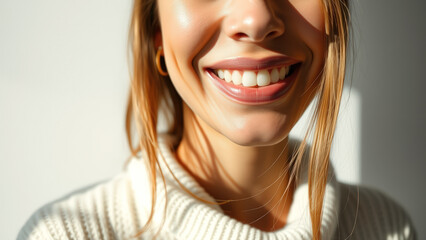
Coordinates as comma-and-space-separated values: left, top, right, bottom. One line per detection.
352, 0, 426, 239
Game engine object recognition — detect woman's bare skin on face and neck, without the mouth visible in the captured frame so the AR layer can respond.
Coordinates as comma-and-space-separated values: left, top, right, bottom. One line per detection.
156, 0, 325, 231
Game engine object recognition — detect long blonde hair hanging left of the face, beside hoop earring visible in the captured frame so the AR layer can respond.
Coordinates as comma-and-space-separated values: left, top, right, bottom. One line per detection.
126, 0, 182, 235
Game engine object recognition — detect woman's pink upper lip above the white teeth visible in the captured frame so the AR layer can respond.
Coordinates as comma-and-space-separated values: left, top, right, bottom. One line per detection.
207, 56, 299, 70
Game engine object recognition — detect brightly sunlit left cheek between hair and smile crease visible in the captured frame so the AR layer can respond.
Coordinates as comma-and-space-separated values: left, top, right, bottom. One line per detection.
158, 0, 218, 100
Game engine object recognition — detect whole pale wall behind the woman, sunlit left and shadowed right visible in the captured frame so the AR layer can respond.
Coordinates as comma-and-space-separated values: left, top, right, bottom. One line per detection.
0, 0, 426, 239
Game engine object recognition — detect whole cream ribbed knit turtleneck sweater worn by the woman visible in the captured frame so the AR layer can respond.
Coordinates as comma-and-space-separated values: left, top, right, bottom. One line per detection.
18, 138, 416, 240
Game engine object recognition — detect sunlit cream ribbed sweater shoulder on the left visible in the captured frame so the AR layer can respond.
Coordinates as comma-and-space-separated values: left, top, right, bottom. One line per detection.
18, 173, 143, 240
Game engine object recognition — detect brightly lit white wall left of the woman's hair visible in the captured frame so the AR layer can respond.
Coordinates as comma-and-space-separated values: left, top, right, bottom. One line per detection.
0, 0, 130, 239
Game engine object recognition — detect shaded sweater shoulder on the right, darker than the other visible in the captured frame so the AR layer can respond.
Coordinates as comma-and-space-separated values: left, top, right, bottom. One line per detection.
335, 183, 416, 239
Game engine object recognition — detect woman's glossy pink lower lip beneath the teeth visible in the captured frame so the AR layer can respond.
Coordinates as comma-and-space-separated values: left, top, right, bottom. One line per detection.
207, 65, 300, 104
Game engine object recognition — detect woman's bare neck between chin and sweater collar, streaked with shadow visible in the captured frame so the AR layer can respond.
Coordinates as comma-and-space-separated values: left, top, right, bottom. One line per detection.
177, 105, 293, 231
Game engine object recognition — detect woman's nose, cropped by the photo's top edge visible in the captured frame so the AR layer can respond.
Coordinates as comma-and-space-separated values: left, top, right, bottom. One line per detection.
223, 0, 284, 42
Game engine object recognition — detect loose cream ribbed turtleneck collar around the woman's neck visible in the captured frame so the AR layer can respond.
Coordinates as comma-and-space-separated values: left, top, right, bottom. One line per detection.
128, 136, 339, 240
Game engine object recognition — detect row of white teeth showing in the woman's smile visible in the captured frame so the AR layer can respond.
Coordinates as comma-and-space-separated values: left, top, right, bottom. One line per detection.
215, 66, 290, 87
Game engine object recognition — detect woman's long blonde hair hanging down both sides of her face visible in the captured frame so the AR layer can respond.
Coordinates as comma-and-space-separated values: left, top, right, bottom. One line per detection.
126, 0, 349, 240
